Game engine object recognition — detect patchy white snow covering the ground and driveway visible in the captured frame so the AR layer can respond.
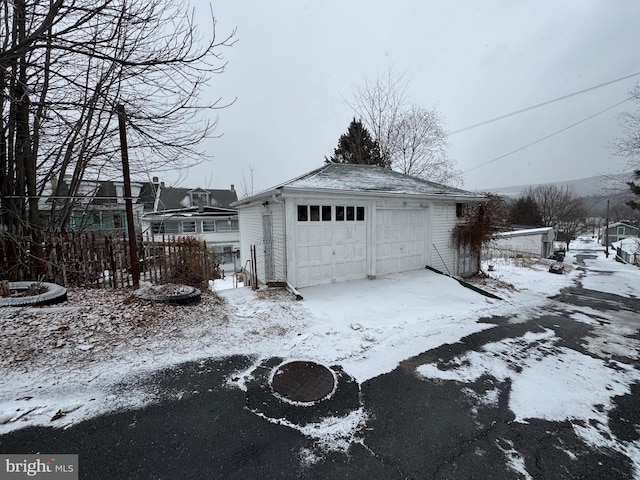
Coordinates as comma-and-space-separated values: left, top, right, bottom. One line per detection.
0, 239, 640, 471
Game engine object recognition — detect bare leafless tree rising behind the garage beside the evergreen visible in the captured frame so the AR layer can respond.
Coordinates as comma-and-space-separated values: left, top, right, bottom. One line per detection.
350, 70, 462, 185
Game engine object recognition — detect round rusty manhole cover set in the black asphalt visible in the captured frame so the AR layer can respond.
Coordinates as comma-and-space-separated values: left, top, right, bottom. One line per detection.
271, 361, 335, 402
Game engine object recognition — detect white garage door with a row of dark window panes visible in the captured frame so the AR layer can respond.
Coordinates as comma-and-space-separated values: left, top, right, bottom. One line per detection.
295, 205, 367, 287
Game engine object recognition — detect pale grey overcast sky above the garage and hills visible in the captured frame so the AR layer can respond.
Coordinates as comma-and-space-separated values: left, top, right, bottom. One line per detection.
161, 0, 640, 193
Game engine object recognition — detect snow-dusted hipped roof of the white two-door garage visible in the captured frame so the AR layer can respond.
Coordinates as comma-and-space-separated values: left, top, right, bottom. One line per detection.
238, 163, 484, 204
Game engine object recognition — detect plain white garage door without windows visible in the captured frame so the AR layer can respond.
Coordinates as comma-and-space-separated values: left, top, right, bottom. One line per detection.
375, 209, 427, 275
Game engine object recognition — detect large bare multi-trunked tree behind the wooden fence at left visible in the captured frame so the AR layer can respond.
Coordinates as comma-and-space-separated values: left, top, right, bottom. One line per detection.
0, 0, 234, 235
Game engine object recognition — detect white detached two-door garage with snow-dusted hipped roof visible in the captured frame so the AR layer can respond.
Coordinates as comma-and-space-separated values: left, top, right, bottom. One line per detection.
232, 163, 486, 288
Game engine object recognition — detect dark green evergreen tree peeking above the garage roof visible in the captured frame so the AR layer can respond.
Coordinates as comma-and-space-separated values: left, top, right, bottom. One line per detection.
325, 118, 389, 167
